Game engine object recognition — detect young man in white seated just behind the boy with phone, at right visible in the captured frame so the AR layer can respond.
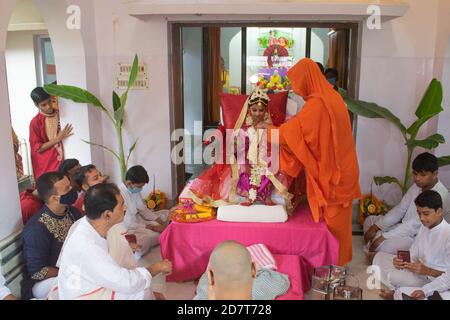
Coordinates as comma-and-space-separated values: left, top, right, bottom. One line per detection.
364, 153, 450, 254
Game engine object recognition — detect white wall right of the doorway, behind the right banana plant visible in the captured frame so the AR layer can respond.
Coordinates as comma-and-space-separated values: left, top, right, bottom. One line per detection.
357, 0, 450, 203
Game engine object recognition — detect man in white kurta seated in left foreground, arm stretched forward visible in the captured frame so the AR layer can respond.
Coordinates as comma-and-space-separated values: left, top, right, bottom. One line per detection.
54, 184, 172, 300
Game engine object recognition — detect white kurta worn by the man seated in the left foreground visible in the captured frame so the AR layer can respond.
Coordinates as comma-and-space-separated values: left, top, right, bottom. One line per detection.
58, 217, 152, 300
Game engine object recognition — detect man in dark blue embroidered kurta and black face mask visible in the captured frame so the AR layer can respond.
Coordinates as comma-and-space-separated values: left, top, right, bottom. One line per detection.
22, 172, 81, 299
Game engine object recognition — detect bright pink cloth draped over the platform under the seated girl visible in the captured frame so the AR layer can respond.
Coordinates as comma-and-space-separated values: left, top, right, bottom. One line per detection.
160, 208, 339, 296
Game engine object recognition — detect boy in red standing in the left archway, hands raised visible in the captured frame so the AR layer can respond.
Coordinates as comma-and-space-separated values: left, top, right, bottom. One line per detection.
29, 87, 73, 180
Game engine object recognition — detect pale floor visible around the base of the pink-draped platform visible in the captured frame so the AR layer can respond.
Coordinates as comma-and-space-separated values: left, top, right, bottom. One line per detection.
139, 236, 381, 300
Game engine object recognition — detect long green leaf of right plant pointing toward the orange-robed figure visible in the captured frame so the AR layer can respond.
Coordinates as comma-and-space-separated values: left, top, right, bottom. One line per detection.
344, 98, 406, 135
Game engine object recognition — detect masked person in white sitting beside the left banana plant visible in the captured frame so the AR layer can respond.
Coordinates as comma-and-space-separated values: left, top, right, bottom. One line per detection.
120, 166, 169, 259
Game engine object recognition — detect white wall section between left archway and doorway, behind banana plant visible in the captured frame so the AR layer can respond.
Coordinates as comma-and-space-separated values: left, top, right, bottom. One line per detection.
91, 0, 174, 197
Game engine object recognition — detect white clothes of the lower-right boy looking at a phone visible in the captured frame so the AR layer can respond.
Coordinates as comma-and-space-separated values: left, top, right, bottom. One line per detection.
374, 220, 450, 297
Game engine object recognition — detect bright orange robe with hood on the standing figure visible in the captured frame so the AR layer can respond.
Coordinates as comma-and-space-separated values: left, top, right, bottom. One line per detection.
272, 59, 361, 265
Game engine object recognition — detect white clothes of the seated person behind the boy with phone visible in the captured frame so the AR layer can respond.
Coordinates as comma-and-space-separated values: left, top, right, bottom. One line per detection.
370, 181, 450, 239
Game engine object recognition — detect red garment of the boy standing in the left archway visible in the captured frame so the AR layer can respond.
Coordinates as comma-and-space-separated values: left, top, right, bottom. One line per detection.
29, 113, 64, 181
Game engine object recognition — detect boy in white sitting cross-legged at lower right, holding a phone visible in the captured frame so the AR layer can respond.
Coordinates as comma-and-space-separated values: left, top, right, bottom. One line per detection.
374, 190, 450, 299
